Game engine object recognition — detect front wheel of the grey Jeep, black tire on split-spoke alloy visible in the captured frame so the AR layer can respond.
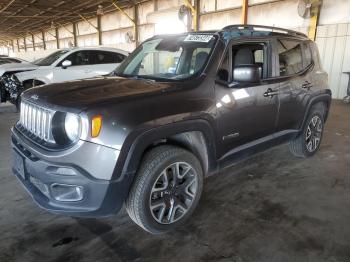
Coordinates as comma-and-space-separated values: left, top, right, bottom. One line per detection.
125, 145, 203, 234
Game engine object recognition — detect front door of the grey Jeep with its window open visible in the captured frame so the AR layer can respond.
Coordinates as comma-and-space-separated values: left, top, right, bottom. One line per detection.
215, 42, 279, 158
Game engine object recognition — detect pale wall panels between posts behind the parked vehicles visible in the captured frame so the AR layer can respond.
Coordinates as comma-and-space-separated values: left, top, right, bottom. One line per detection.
0, 0, 350, 99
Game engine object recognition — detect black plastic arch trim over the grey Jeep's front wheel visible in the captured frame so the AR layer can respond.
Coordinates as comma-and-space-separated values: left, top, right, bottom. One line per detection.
113, 120, 217, 180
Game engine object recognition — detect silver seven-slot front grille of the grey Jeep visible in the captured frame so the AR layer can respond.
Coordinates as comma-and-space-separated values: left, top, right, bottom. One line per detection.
19, 101, 55, 143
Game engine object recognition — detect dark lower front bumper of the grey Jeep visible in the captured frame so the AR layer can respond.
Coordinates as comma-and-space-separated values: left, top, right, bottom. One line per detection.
12, 127, 131, 217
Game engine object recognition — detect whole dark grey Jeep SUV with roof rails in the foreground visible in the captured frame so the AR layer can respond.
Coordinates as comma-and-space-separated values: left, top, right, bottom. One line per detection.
12, 25, 331, 233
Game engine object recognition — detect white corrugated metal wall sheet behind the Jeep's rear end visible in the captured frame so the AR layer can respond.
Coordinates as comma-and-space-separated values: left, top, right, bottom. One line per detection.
316, 23, 350, 99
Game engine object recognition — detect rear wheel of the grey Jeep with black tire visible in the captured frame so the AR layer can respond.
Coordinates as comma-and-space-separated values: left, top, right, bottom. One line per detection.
289, 103, 326, 158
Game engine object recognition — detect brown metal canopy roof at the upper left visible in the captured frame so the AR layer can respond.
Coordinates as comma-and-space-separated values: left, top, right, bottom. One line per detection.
0, 0, 144, 41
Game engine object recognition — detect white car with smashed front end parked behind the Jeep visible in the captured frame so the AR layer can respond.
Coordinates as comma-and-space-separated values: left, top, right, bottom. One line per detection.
0, 47, 128, 106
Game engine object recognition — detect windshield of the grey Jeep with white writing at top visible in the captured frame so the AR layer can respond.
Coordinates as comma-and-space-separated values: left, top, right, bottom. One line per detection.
116, 34, 216, 80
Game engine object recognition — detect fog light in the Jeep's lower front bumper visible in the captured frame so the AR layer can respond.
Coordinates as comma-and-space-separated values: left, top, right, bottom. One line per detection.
51, 184, 83, 202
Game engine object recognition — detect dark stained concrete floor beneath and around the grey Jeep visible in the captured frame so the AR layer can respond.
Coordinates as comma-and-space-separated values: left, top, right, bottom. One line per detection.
0, 102, 350, 262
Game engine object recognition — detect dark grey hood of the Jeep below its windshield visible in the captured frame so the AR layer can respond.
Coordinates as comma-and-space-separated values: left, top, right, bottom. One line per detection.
22, 77, 178, 112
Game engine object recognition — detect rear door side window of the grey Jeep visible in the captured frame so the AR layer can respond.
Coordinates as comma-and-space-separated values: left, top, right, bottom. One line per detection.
277, 39, 303, 76
